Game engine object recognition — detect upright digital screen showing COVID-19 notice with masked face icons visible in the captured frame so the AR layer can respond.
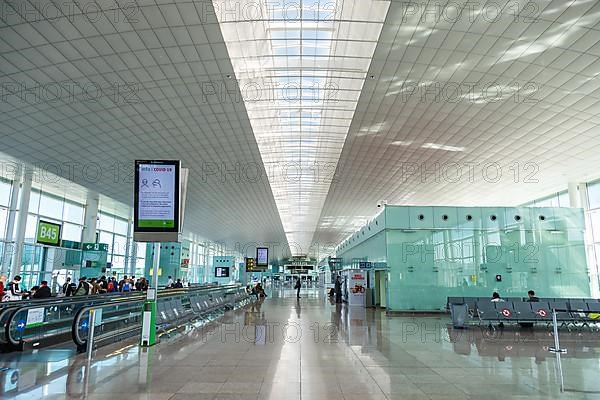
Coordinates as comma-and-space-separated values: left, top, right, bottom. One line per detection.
135, 160, 180, 232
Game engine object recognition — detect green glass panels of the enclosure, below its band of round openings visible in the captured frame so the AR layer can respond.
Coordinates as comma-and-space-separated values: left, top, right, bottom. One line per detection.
337, 208, 600, 311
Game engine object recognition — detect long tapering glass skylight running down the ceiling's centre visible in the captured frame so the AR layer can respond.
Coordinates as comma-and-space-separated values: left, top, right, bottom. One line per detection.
213, 0, 390, 255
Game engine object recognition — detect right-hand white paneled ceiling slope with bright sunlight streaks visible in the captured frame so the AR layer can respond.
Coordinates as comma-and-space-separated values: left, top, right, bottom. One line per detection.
313, 0, 600, 248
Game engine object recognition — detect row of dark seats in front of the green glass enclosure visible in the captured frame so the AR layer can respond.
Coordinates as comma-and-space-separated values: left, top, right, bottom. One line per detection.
448, 298, 600, 327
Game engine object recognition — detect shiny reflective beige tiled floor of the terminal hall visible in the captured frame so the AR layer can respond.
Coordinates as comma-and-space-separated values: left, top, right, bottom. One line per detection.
0, 289, 600, 400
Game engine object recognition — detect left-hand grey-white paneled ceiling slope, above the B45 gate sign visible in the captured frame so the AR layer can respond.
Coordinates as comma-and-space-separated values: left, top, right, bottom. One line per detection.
0, 1, 286, 257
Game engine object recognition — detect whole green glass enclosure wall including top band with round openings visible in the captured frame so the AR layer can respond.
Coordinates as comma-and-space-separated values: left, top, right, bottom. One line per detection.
337, 206, 590, 310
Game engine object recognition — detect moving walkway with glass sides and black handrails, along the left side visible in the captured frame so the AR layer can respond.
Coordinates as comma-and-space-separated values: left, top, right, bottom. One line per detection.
0, 285, 250, 352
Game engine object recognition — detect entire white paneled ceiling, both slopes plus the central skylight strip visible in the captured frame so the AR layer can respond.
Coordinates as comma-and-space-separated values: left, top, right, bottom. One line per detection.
0, 0, 600, 262
